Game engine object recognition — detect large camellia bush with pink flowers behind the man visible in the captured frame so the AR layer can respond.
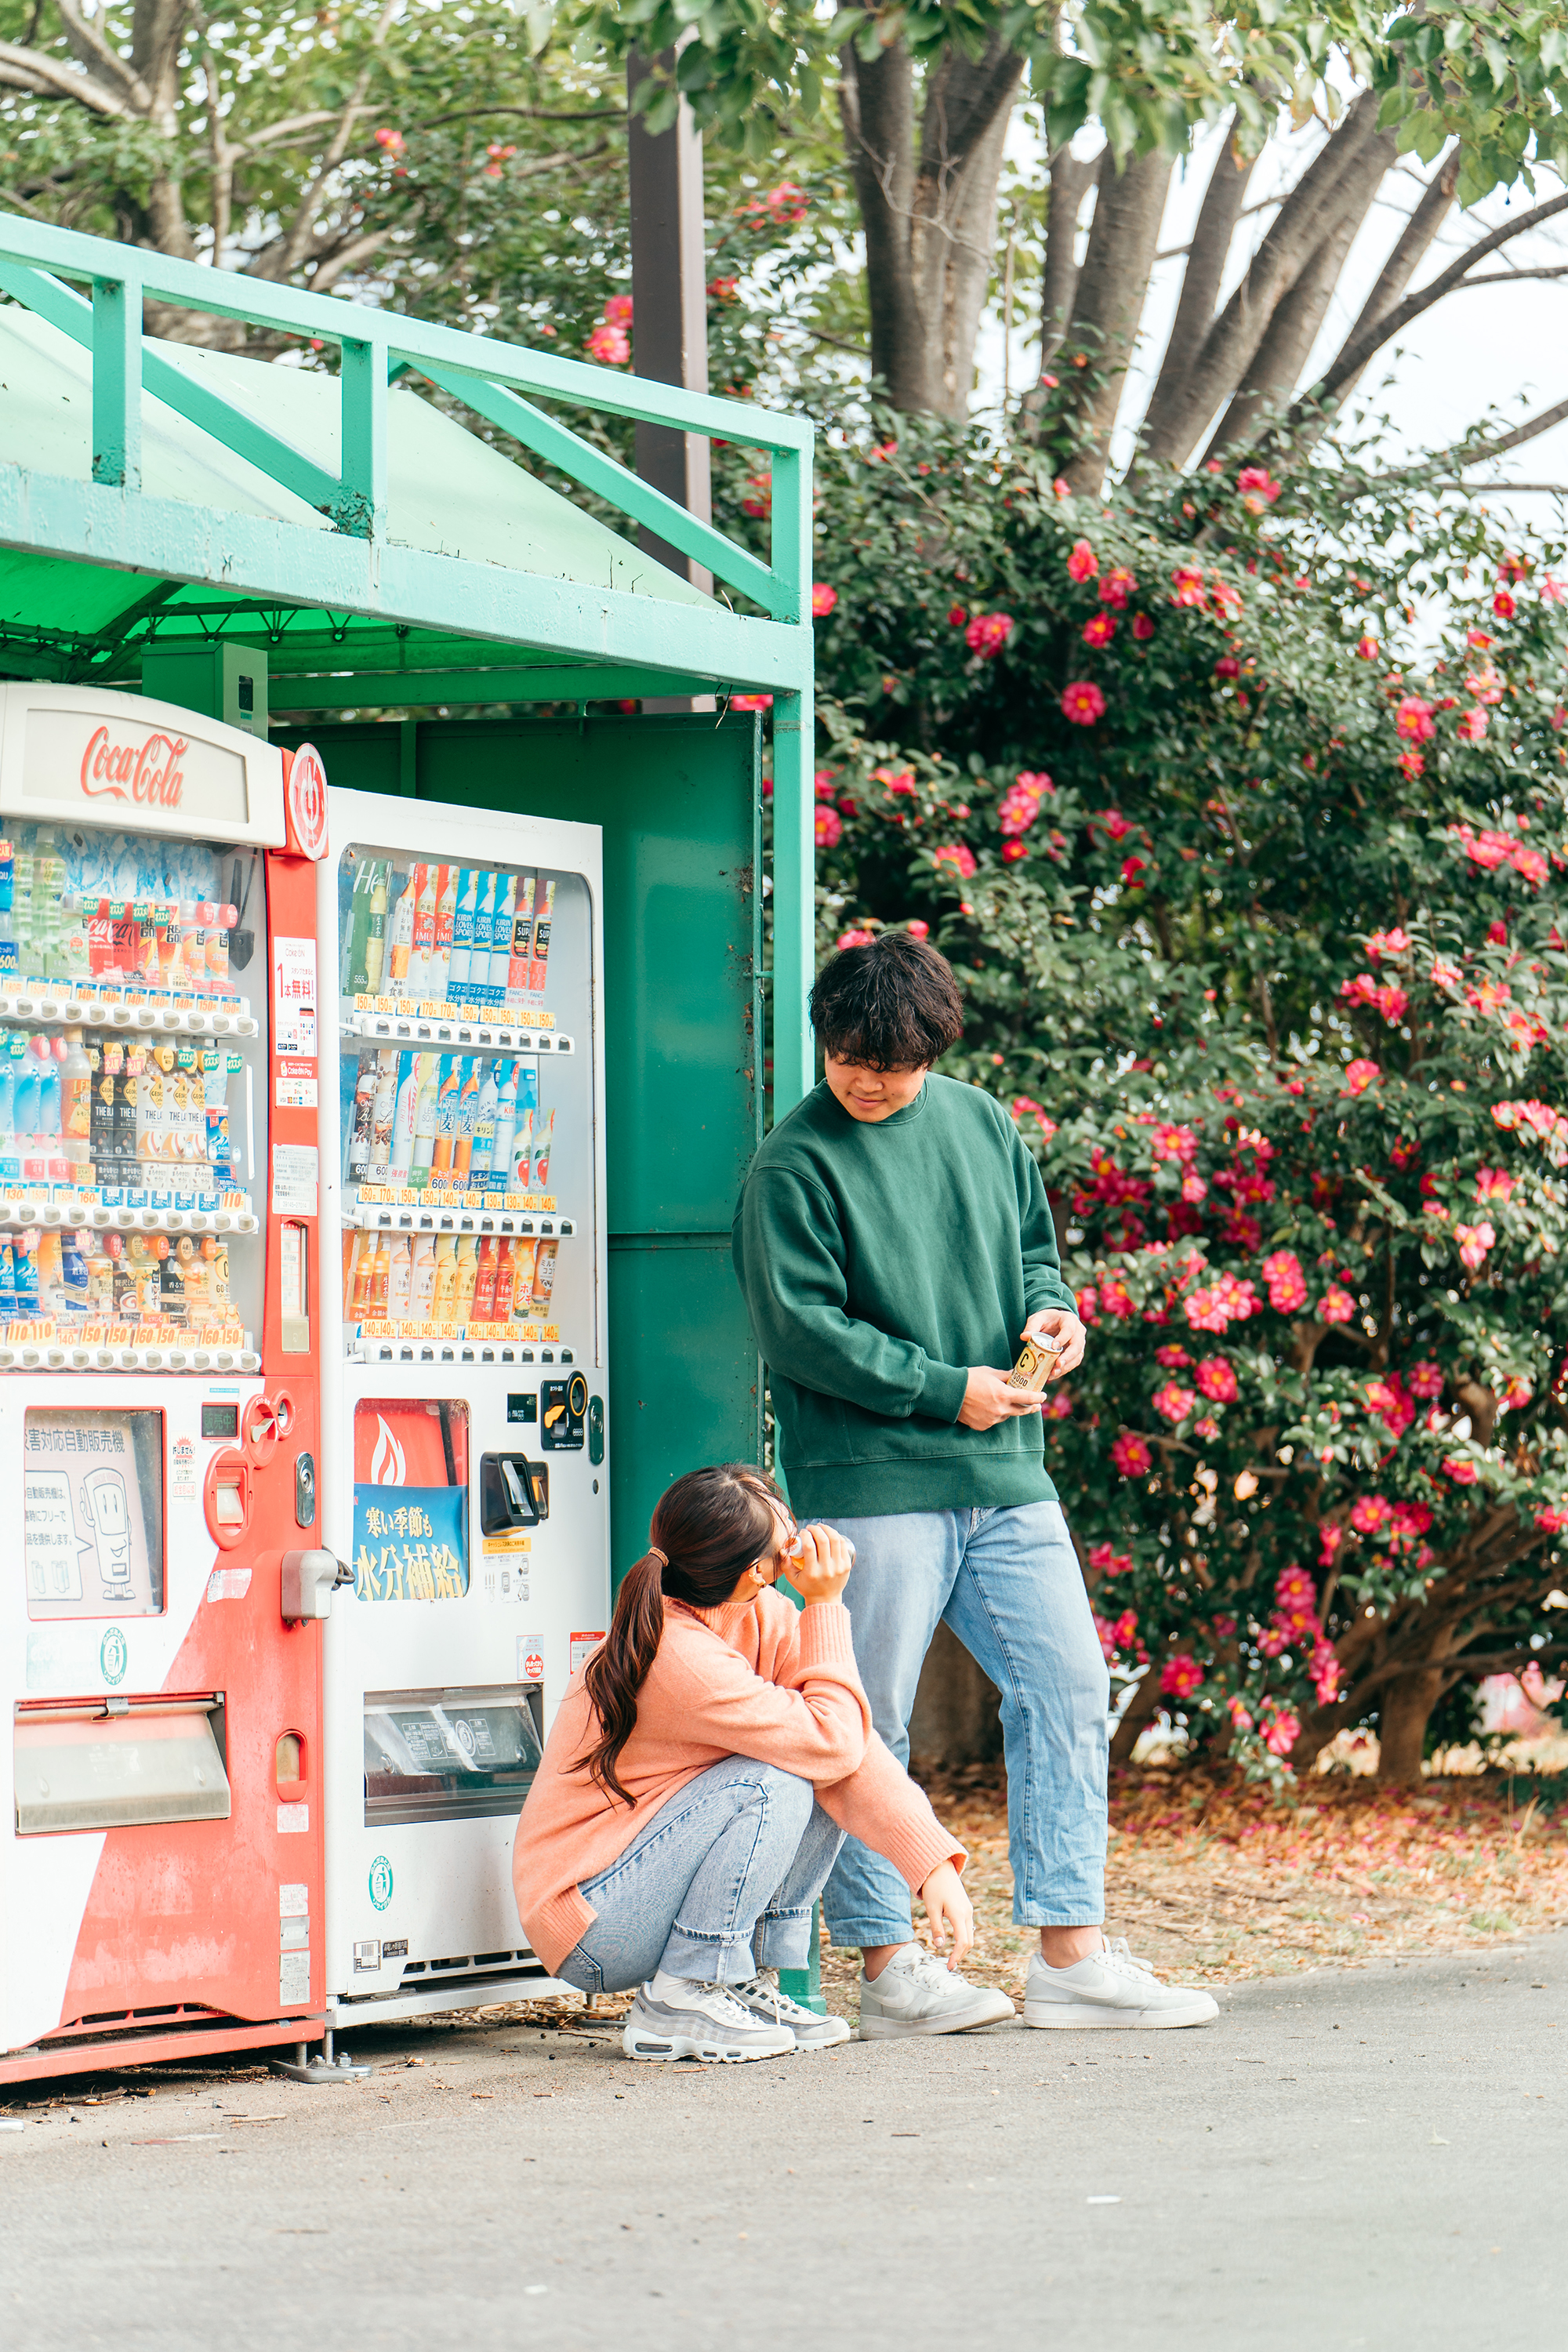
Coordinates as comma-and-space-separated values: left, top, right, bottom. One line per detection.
799, 421, 1568, 1778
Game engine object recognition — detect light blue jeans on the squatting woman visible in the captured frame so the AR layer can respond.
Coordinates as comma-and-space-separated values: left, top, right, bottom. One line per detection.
557, 1757, 844, 1992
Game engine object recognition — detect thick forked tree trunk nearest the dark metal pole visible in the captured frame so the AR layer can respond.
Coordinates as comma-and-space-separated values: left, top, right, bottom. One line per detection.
839, 24, 1022, 421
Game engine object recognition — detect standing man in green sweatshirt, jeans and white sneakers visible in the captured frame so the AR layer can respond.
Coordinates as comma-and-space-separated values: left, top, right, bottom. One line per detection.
734, 931, 1218, 2039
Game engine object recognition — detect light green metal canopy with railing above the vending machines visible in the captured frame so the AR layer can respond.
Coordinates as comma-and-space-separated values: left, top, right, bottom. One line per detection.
0, 219, 813, 1110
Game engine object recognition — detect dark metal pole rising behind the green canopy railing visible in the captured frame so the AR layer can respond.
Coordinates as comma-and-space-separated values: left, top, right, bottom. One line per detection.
626, 49, 713, 597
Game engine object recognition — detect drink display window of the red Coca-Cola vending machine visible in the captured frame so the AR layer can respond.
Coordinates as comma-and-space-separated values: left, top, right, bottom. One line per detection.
0, 818, 266, 1369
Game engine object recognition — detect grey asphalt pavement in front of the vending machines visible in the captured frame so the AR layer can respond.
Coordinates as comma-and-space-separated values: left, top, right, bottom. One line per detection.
0, 1933, 1568, 2352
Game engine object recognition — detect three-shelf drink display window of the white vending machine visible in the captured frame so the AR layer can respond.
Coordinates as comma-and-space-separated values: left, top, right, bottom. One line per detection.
339, 844, 593, 1362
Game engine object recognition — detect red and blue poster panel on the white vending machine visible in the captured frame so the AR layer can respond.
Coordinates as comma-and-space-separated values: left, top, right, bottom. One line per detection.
353, 1397, 468, 1602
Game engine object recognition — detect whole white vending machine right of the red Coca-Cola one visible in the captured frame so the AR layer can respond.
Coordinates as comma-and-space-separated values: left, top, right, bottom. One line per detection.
320, 793, 609, 2023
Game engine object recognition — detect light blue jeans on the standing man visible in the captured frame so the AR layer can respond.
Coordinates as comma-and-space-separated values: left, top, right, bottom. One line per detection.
822, 1503, 1109, 1945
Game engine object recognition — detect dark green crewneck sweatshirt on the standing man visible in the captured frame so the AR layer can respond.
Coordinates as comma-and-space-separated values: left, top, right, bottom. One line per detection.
734, 1077, 1074, 1519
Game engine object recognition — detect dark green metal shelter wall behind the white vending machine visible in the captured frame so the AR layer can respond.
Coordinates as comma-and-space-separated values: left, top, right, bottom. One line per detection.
292, 713, 762, 1578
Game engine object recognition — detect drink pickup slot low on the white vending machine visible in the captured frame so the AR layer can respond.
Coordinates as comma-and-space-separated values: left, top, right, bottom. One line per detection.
365, 1682, 546, 1828
